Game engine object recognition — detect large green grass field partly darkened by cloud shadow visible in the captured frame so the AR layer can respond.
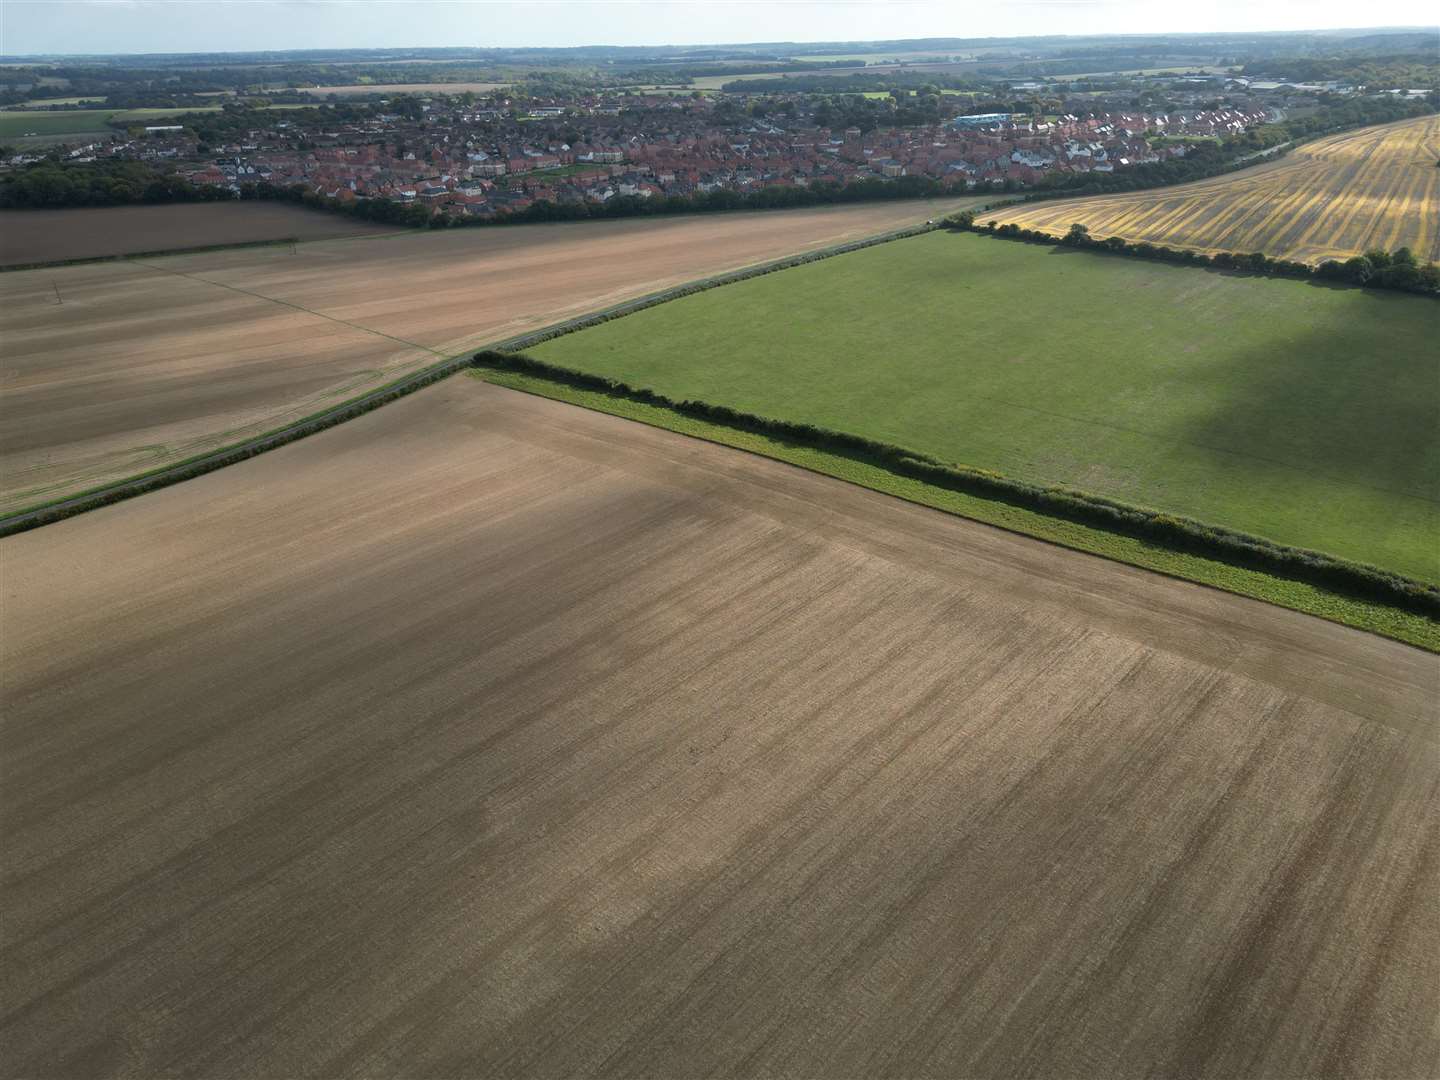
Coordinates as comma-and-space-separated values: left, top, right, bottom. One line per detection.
527, 233, 1440, 580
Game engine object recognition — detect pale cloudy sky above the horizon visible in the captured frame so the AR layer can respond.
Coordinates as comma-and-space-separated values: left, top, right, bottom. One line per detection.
0, 0, 1436, 56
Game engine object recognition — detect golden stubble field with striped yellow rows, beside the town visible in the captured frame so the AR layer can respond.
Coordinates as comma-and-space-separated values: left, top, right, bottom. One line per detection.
985, 117, 1440, 264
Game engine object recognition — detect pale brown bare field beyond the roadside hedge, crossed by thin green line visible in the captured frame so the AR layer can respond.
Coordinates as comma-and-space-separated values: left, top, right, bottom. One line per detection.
0, 200, 973, 510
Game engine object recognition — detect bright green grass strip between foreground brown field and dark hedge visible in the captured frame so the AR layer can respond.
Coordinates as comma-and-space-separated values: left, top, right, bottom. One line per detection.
471, 367, 1440, 652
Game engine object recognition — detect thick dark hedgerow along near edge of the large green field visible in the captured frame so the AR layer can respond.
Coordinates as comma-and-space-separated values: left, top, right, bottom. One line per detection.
474, 350, 1440, 618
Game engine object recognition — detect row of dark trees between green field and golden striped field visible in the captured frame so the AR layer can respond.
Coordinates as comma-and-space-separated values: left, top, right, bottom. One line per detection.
945, 210, 1440, 297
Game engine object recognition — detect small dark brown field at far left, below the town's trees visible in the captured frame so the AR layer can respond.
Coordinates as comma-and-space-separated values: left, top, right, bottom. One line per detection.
0, 203, 400, 266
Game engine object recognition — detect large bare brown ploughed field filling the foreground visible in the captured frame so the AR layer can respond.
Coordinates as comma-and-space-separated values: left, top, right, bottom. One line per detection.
0, 377, 1440, 1080
